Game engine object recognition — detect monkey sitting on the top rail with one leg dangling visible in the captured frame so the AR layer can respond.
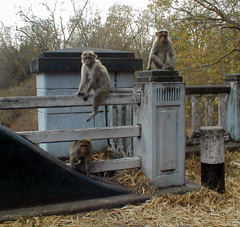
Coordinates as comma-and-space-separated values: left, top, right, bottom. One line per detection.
76, 50, 110, 122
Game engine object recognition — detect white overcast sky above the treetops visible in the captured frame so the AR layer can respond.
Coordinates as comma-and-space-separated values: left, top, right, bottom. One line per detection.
0, 0, 150, 26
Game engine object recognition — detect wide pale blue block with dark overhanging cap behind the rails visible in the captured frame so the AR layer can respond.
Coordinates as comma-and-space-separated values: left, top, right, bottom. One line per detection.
30, 47, 142, 157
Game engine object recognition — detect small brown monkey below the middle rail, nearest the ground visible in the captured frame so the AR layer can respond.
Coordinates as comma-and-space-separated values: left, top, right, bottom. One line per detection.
69, 139, 92, 177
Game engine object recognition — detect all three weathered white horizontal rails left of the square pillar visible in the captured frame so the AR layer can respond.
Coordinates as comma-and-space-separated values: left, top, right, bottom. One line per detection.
0, 93, 141, 173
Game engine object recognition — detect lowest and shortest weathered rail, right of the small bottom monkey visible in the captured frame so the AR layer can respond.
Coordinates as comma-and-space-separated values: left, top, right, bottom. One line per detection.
70, 157, 141, 173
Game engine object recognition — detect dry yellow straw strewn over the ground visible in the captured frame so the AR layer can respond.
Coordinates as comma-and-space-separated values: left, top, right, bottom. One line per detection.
0, 152, 240, 227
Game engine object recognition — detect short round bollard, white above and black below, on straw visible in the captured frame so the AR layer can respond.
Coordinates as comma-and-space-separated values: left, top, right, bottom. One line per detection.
200, 126, 225, 193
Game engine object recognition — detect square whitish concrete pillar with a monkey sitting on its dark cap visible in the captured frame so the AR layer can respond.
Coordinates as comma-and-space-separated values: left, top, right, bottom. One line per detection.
134, 70, 185, 187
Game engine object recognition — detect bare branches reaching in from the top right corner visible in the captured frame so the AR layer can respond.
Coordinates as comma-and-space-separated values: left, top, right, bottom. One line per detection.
172, 0, 240, 55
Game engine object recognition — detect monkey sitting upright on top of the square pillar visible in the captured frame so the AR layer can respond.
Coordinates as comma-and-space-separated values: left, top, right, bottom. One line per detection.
147, 30, 176, 70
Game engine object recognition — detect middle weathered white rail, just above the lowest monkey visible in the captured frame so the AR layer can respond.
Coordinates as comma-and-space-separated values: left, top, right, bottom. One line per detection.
17, 125, 141, 143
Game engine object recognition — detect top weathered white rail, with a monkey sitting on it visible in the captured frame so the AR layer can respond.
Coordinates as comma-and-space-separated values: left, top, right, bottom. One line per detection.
0, 93, 140, 110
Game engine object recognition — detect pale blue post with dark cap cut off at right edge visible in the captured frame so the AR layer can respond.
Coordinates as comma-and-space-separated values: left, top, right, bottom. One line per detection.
225, 74, 240, 141
